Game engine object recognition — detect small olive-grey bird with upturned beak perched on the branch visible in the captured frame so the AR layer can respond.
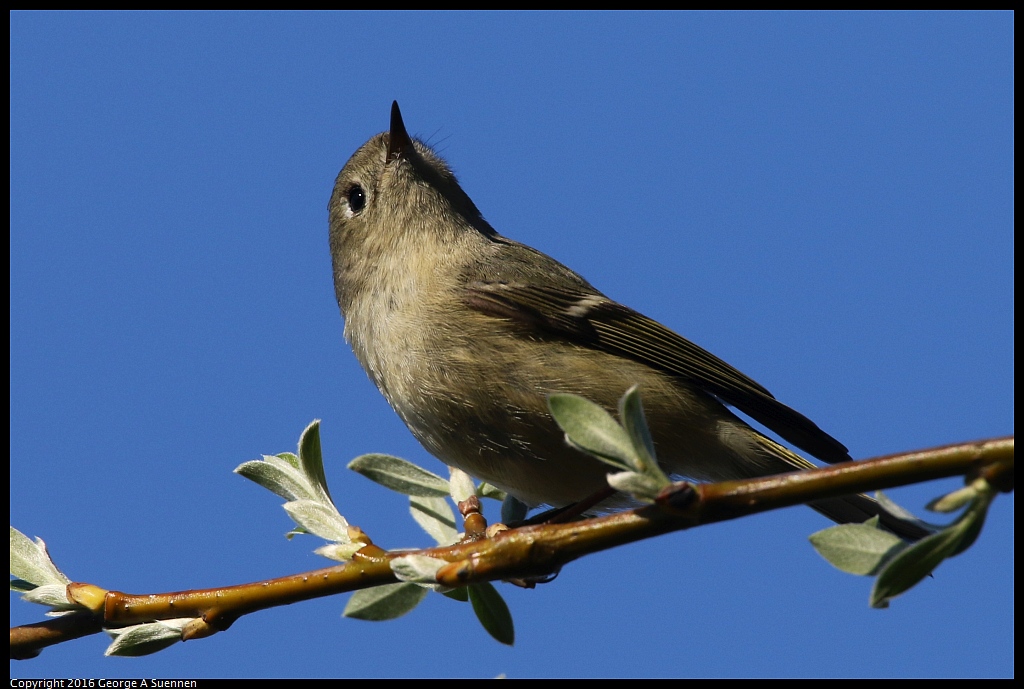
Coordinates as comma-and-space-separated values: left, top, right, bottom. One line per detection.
329, 103, 923, 537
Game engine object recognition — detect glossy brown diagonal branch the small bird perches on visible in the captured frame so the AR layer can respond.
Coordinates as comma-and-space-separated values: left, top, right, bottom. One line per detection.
10, 436, 1014, 658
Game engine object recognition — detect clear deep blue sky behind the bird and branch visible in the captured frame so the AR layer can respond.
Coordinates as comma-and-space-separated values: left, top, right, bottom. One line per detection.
10, 13, 1014, 678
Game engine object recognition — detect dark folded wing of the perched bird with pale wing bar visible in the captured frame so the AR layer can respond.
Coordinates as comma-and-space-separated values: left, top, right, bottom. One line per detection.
466, 274, 850, 462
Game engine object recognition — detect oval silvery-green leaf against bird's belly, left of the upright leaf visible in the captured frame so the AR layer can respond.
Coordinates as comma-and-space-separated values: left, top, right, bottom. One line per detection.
548, 394, 639, 470
